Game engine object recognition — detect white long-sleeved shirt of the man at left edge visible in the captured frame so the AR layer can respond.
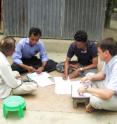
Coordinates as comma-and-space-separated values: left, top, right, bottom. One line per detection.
0, 52, 21, 98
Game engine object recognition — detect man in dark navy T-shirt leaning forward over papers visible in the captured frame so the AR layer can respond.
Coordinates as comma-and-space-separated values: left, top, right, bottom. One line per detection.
64, 31, 98, 79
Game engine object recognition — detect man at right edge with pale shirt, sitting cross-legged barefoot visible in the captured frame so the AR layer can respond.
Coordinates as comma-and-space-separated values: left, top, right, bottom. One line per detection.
78, 38, 117, 112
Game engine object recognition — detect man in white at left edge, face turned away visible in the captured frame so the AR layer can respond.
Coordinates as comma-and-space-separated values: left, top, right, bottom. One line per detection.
0, 37, 37, 98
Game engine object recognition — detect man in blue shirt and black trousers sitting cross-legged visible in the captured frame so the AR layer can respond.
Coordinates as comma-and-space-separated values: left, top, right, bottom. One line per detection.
11, 27, 56, 74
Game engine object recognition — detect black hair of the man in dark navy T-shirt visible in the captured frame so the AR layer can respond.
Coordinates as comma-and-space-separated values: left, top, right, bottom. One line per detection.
74, 30, 88, 42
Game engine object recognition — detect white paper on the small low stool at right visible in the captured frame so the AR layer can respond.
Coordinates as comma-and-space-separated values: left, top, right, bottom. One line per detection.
71, 81, 91, 98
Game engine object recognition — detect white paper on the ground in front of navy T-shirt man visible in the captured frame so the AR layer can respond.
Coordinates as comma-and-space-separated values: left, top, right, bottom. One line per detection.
54, 77, 71, 94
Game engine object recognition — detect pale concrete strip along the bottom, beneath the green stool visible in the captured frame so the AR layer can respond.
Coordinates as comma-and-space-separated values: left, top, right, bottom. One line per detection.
0, 110, 117, 124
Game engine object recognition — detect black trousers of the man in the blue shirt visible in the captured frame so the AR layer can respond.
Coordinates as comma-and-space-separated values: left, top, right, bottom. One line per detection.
11, 56, 57, 74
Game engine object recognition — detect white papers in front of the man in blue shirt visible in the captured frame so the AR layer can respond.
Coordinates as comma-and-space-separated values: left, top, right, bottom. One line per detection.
27, 72, 54, 87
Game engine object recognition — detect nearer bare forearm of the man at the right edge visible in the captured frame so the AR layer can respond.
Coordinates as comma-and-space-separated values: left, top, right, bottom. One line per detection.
78, 87, 115, 100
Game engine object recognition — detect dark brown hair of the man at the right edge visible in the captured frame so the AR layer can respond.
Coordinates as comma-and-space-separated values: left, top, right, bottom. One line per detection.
97, 37, 117, 56
